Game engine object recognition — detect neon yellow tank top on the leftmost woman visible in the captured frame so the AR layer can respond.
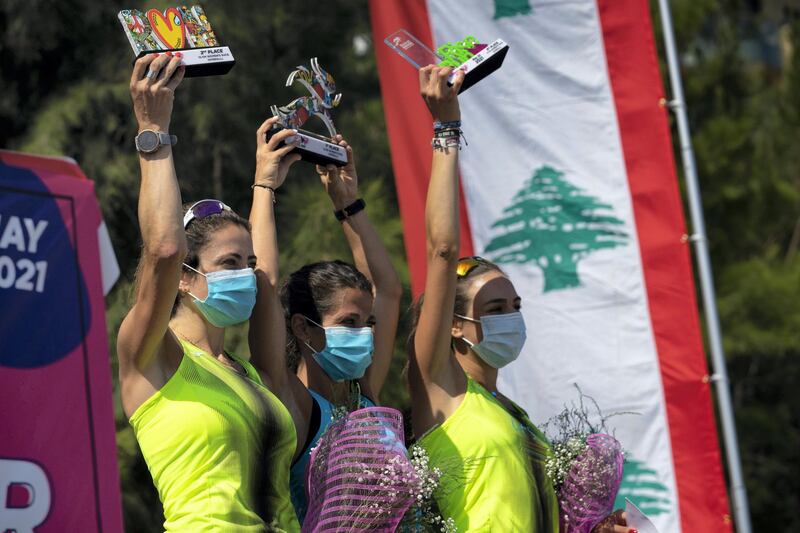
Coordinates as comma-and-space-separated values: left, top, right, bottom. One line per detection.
130, 341, 300, 532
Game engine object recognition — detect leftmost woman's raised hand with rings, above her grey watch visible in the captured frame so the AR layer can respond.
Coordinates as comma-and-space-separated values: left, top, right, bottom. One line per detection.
130, 52, 186, 133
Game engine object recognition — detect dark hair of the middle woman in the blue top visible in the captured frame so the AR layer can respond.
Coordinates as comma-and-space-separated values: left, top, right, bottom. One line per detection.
281, 261, 372, 370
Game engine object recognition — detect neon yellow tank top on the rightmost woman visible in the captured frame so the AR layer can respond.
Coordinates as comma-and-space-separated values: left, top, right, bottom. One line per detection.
419, 378, 558, 533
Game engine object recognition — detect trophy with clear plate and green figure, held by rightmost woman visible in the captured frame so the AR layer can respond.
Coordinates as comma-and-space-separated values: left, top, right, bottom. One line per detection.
383, 29, 508, 93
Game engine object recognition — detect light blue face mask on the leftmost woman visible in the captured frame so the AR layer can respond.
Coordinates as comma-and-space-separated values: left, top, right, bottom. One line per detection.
184, 263, 256, 328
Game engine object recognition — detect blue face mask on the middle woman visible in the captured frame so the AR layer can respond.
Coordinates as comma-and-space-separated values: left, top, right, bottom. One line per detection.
305, 317, 375, 381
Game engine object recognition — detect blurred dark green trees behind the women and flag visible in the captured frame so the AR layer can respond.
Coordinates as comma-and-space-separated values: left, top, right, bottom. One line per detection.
0, 0, 800, 532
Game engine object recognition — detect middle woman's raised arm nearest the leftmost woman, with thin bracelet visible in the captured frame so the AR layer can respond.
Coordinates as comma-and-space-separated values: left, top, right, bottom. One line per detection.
248, 117, 300, 394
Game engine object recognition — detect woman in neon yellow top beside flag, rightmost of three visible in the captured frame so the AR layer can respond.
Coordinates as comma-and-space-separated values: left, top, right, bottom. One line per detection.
409, 66, 628, 533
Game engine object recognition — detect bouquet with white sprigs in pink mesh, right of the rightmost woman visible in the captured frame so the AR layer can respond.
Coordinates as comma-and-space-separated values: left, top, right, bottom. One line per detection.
543, 390, 625, 533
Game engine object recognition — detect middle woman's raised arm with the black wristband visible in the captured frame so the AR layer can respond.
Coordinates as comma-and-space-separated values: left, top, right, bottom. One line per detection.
317, 135, 403, 401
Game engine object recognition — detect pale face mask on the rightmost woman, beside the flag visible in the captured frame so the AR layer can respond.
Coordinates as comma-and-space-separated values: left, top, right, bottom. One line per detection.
455, 311, 527, 368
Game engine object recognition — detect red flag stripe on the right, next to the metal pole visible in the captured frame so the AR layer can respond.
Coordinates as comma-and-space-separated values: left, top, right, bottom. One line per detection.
598, 0, 731, 532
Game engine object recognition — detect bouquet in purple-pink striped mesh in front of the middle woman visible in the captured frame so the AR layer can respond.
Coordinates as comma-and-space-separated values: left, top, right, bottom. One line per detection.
303, 407, 456, 533
